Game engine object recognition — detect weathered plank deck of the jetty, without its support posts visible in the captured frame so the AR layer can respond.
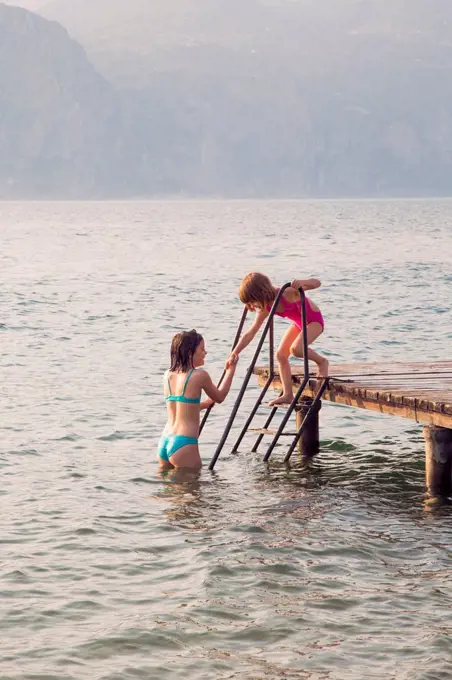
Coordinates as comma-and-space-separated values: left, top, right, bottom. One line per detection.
255, 361, 452, 428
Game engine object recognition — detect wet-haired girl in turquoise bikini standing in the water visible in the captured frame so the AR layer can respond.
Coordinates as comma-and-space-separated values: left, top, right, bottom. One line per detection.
158, 330, 237, 469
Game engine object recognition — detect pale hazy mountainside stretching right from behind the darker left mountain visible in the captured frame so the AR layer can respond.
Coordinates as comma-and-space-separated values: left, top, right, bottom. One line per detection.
38, 0, 452, 194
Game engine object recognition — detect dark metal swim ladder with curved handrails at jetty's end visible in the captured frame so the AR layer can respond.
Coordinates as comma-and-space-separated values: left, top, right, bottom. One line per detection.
200, 283, 329, 470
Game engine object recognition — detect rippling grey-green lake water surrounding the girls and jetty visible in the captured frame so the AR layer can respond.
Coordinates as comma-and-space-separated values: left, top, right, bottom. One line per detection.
0, 200, 452, 680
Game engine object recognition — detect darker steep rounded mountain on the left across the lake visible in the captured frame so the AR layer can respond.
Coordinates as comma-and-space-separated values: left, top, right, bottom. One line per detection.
0, 4, 141, 197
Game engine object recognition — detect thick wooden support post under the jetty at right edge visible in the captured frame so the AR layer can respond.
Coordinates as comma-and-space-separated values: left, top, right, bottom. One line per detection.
423, 426, 452, 498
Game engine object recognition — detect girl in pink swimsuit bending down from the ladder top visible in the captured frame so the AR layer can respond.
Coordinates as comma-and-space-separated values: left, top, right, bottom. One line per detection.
227, 272, 328, 405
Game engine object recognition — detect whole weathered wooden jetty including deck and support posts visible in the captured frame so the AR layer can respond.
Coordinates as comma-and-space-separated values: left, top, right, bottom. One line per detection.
254, 361, 452, 496
